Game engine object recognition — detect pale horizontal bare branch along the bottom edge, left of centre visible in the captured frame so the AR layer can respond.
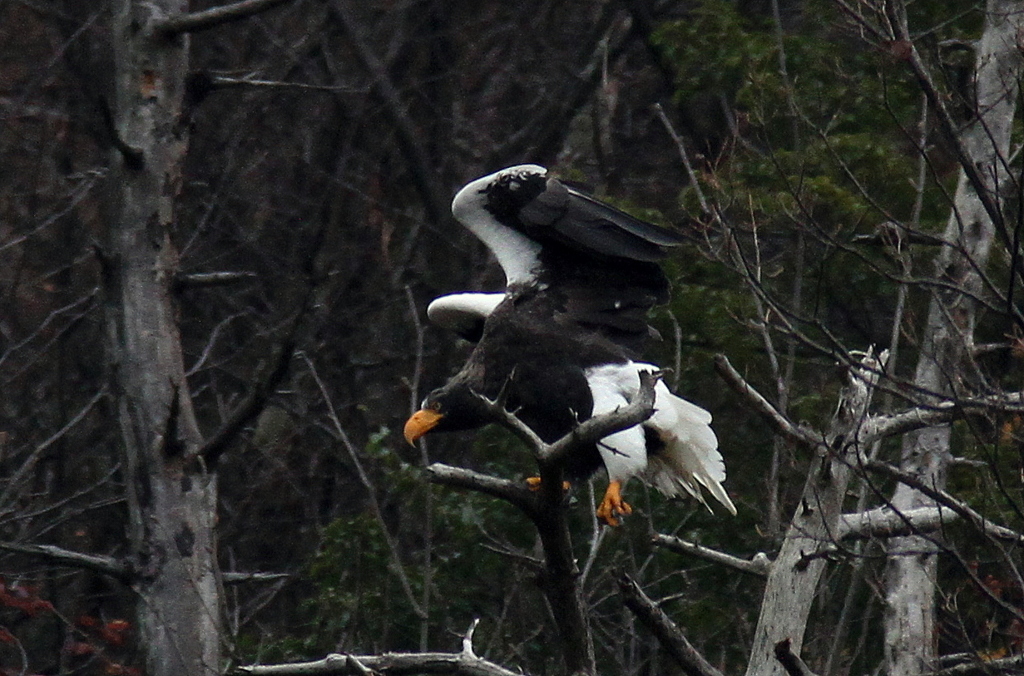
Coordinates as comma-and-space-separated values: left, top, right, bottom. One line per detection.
237, 651, 524, 676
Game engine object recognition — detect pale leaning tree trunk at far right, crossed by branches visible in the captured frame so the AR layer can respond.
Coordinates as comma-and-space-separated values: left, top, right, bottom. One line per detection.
885, 0, 1024, 676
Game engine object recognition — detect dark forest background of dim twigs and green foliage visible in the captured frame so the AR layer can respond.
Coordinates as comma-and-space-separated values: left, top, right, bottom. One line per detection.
0, 0, 1024, 676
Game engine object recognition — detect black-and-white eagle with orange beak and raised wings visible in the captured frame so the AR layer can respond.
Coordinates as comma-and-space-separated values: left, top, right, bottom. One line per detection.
404, 164, 736, 525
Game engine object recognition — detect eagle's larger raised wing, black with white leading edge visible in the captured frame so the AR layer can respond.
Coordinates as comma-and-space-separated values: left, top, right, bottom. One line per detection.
452, 165, 682, 353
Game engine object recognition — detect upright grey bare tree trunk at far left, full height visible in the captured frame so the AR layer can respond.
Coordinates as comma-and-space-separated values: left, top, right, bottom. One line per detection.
104, 0, 220, 676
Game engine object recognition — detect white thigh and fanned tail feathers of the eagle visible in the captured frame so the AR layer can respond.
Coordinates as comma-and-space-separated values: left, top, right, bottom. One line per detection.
587, 362, 736, 514
